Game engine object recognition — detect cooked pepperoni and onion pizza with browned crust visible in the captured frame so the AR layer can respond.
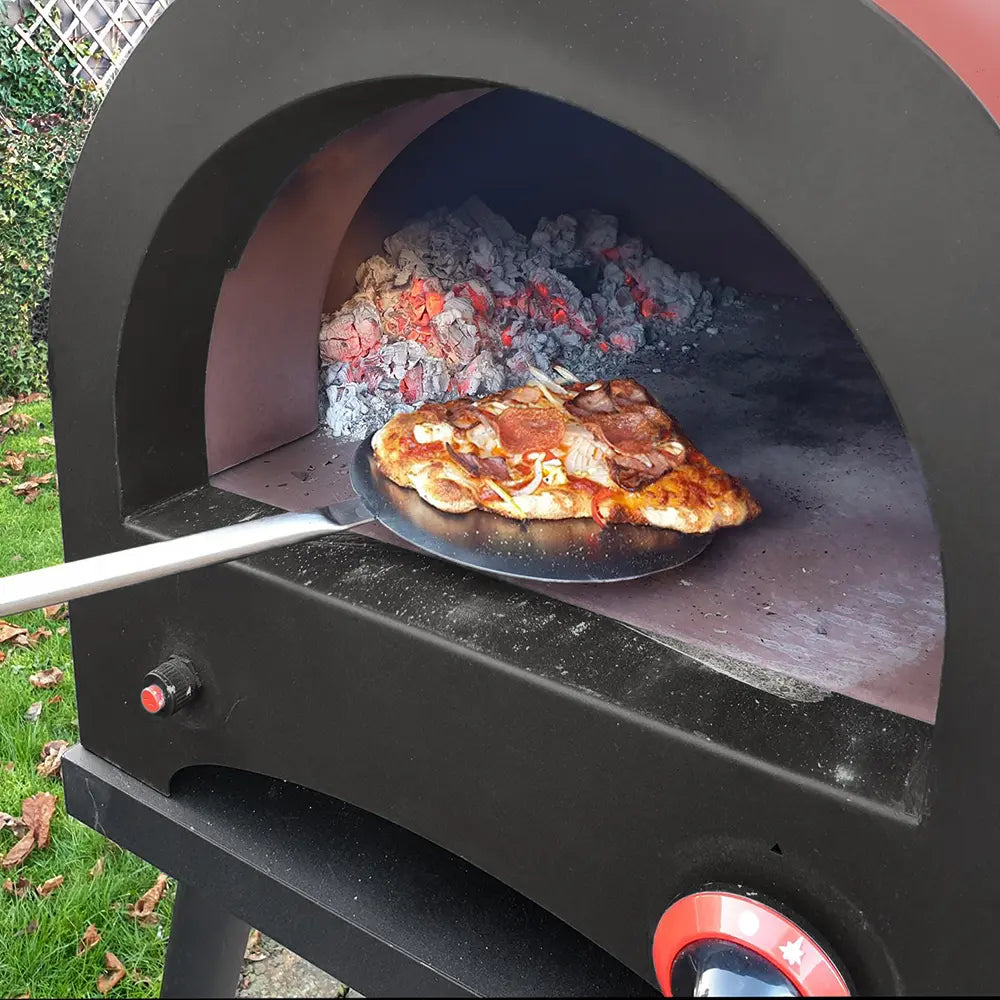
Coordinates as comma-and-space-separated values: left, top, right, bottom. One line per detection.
372, 373, 760, 533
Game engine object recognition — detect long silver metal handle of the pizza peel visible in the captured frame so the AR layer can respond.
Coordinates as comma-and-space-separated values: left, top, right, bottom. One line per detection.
0, 503, 371, 616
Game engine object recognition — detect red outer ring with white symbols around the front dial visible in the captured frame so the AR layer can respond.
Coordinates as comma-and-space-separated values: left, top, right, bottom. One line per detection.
653, 892, 851, 997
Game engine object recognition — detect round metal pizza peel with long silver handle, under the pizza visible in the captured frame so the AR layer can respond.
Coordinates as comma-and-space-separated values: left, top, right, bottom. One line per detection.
0, 437, 712, 616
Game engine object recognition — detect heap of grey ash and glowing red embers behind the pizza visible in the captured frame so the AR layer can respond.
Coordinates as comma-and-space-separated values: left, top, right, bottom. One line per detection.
319, 198, 735, 440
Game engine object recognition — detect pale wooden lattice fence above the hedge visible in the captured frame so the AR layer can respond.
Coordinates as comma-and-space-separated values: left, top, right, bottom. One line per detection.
6, 0, 173, 91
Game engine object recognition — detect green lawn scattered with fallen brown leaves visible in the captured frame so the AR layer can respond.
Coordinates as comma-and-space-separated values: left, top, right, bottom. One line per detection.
0, 400, 171, 997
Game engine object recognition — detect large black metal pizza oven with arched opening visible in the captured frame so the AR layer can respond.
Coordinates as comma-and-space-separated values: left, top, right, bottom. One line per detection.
45, 0, 1000, 993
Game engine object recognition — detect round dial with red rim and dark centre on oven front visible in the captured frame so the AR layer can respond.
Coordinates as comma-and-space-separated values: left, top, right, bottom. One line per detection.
653, 891, 851, 997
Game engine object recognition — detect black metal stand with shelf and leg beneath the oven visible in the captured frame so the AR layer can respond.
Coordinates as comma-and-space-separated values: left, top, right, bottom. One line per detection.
62, 745, 660, 997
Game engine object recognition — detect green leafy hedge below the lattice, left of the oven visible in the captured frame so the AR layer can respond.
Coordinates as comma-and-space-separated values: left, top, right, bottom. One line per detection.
0, 26, 96, 398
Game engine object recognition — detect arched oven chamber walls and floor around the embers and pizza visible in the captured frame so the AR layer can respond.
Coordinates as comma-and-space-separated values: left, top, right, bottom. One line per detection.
205, 89, 945, 722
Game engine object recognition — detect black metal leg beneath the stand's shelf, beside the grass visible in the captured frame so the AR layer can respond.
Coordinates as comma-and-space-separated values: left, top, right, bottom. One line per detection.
160, 882, 250, 998
